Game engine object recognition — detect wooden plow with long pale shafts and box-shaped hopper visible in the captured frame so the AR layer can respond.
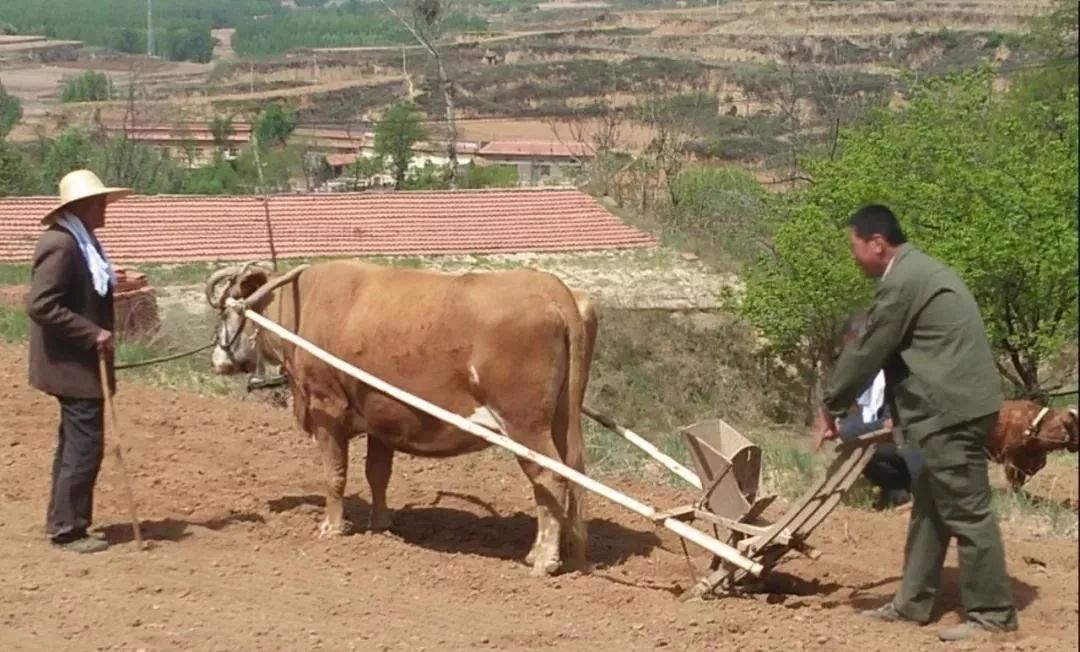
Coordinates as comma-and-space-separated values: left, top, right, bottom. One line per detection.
226, 299, 876, 599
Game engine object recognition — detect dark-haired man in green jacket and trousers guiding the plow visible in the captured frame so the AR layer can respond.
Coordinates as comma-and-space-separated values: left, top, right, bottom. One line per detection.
818, 205, 1017, 640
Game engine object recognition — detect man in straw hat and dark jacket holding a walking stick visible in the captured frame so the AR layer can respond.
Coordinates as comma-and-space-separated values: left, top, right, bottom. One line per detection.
26, 169, 131, 553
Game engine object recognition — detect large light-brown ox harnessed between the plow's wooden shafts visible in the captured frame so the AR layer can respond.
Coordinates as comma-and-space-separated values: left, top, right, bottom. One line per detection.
206, 261, 596, 574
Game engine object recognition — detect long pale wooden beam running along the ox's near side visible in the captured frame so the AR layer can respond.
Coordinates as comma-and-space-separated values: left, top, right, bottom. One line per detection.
227, 299, 765, 576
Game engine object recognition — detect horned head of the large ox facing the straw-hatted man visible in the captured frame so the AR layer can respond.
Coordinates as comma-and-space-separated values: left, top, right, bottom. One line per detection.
206, 262, 271, 375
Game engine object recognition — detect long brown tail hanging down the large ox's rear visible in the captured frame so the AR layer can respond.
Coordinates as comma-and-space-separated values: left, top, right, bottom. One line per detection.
559, 291, 588, 563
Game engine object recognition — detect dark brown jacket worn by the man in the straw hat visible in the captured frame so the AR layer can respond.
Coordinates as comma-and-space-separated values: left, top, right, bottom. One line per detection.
26, 225, 116, 398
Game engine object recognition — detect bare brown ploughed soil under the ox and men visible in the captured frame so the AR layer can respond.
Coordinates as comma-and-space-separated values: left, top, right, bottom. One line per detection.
0, 345, 1078, 652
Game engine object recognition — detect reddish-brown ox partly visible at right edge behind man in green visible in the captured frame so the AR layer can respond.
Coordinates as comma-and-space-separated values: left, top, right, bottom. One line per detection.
989, 400, 1078, 491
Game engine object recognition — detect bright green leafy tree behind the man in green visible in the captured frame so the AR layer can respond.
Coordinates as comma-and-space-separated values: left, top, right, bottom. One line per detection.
743, 67, 1080, 408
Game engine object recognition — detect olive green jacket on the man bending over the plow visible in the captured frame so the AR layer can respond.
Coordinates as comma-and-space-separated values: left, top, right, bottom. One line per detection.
824, 244, 1002, 445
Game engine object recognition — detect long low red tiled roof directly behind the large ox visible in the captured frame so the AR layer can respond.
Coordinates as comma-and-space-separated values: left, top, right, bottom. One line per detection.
0, 189, 657, 262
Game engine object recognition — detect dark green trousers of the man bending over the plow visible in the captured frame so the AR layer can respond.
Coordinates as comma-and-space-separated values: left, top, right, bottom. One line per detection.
893, 413, 1016, 629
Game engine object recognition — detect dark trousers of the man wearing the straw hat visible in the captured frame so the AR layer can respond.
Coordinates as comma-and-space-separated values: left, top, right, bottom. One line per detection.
45, 396, 105, 543
